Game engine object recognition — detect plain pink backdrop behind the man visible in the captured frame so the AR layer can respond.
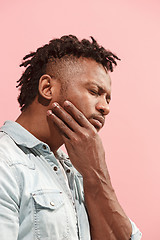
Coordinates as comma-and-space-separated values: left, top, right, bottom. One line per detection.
0, 0, 160, 240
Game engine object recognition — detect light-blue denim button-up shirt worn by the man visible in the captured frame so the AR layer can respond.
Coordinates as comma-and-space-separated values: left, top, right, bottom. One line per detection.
0, 121, 141, 240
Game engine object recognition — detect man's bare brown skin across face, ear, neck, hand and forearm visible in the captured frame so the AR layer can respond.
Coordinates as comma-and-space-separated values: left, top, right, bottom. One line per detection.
17, 59, 132, 240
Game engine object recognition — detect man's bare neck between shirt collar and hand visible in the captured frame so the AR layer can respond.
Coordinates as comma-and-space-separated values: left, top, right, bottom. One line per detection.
16, 106, 63, 153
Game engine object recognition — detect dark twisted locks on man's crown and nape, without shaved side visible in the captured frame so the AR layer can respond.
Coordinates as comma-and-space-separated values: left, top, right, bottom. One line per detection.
17, 35, 120, 111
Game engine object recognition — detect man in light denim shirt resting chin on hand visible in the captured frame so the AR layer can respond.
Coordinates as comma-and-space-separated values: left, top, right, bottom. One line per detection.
0, 35, 141, 240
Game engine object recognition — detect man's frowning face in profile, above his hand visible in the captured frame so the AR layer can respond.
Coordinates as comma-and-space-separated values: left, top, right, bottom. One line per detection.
54, 59, 111, 131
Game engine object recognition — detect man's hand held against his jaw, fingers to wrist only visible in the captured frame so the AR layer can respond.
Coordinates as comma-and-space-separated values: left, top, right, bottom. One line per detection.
49, 101, 106, 177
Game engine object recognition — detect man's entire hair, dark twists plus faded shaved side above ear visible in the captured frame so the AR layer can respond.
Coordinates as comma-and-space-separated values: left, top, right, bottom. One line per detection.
17, 35, 118, 110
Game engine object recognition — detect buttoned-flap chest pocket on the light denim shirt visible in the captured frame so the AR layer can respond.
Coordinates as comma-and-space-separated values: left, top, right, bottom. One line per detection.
31, 190, 69, 240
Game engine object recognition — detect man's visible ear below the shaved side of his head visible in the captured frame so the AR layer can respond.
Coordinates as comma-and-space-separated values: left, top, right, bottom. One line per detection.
38, 74, 53, 100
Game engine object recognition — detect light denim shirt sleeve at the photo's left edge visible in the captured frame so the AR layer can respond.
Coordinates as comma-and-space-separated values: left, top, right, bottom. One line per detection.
0, 157, 19, 240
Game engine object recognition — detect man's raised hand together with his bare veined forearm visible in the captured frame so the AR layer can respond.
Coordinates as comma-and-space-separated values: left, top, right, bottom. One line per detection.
47, 101, 131, 240
